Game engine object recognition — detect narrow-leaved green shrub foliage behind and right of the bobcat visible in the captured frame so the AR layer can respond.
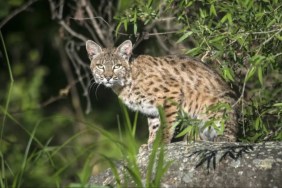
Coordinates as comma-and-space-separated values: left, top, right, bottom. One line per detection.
117, 0, 282, 142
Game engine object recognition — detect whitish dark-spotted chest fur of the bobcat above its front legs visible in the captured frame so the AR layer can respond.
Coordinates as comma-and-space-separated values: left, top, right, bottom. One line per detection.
119, 92, 159, 116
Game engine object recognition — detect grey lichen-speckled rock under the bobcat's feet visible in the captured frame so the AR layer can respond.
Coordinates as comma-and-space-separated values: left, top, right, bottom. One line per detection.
89, 142, 282, 188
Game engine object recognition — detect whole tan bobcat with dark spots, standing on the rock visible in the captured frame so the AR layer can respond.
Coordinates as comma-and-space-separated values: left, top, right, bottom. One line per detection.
86, 40, 238, 145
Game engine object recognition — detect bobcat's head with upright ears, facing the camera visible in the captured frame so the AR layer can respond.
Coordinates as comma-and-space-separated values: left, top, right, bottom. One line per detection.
86, 40, 132, 87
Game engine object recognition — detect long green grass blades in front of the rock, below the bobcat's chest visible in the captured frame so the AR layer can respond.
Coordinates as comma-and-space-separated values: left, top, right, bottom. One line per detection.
99, 103, 172, 187
